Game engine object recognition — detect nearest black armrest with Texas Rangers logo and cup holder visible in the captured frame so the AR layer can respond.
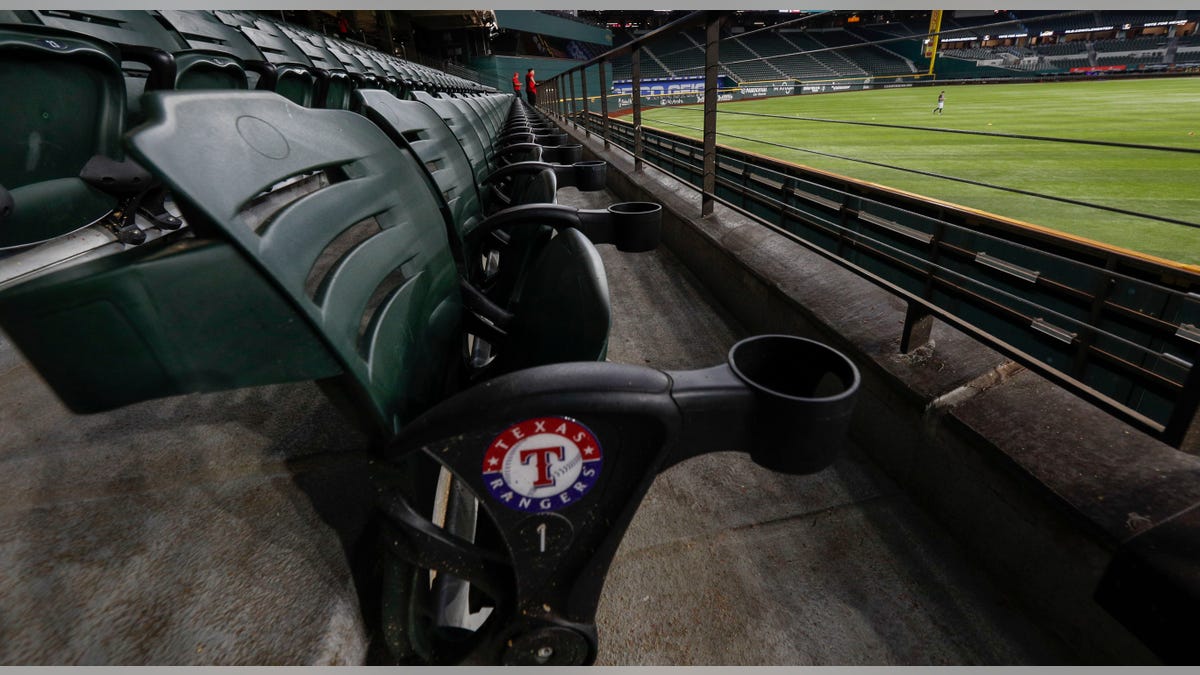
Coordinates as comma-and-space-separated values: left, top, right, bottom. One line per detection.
383, 335, 860, 664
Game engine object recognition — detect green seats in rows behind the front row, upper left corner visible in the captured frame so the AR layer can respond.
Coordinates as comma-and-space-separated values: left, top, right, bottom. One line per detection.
0, 10, 491, 251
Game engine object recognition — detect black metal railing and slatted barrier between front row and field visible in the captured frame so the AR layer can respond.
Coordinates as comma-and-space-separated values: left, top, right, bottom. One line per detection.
544, 11, 1200, 447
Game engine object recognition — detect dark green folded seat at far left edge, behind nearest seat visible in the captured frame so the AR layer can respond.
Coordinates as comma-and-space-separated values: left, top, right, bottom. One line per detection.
0, 25, 125, 247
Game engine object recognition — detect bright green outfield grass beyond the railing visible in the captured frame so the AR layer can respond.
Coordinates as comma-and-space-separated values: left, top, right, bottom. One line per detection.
644, 78, 1200, 264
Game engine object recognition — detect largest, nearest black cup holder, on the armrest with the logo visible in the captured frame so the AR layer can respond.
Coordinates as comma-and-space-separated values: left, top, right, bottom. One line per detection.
728, 335, 862, 473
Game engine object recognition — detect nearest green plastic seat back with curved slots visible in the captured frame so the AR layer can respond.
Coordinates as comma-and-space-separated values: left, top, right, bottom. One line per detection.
128, 91, 462, 434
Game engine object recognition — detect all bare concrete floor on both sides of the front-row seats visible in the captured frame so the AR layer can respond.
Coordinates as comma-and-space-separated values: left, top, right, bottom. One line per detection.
0, 182, 1074, 665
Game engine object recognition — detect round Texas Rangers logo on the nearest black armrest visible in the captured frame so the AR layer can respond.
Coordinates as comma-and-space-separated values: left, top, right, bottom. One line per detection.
484, 417, 602, 513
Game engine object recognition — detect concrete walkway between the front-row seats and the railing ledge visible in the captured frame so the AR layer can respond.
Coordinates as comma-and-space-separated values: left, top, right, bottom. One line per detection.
598, 237, 1073, 665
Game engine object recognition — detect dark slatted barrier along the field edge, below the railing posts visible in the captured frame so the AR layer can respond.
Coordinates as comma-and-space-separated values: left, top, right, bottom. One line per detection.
564, 105, 1200, 447
